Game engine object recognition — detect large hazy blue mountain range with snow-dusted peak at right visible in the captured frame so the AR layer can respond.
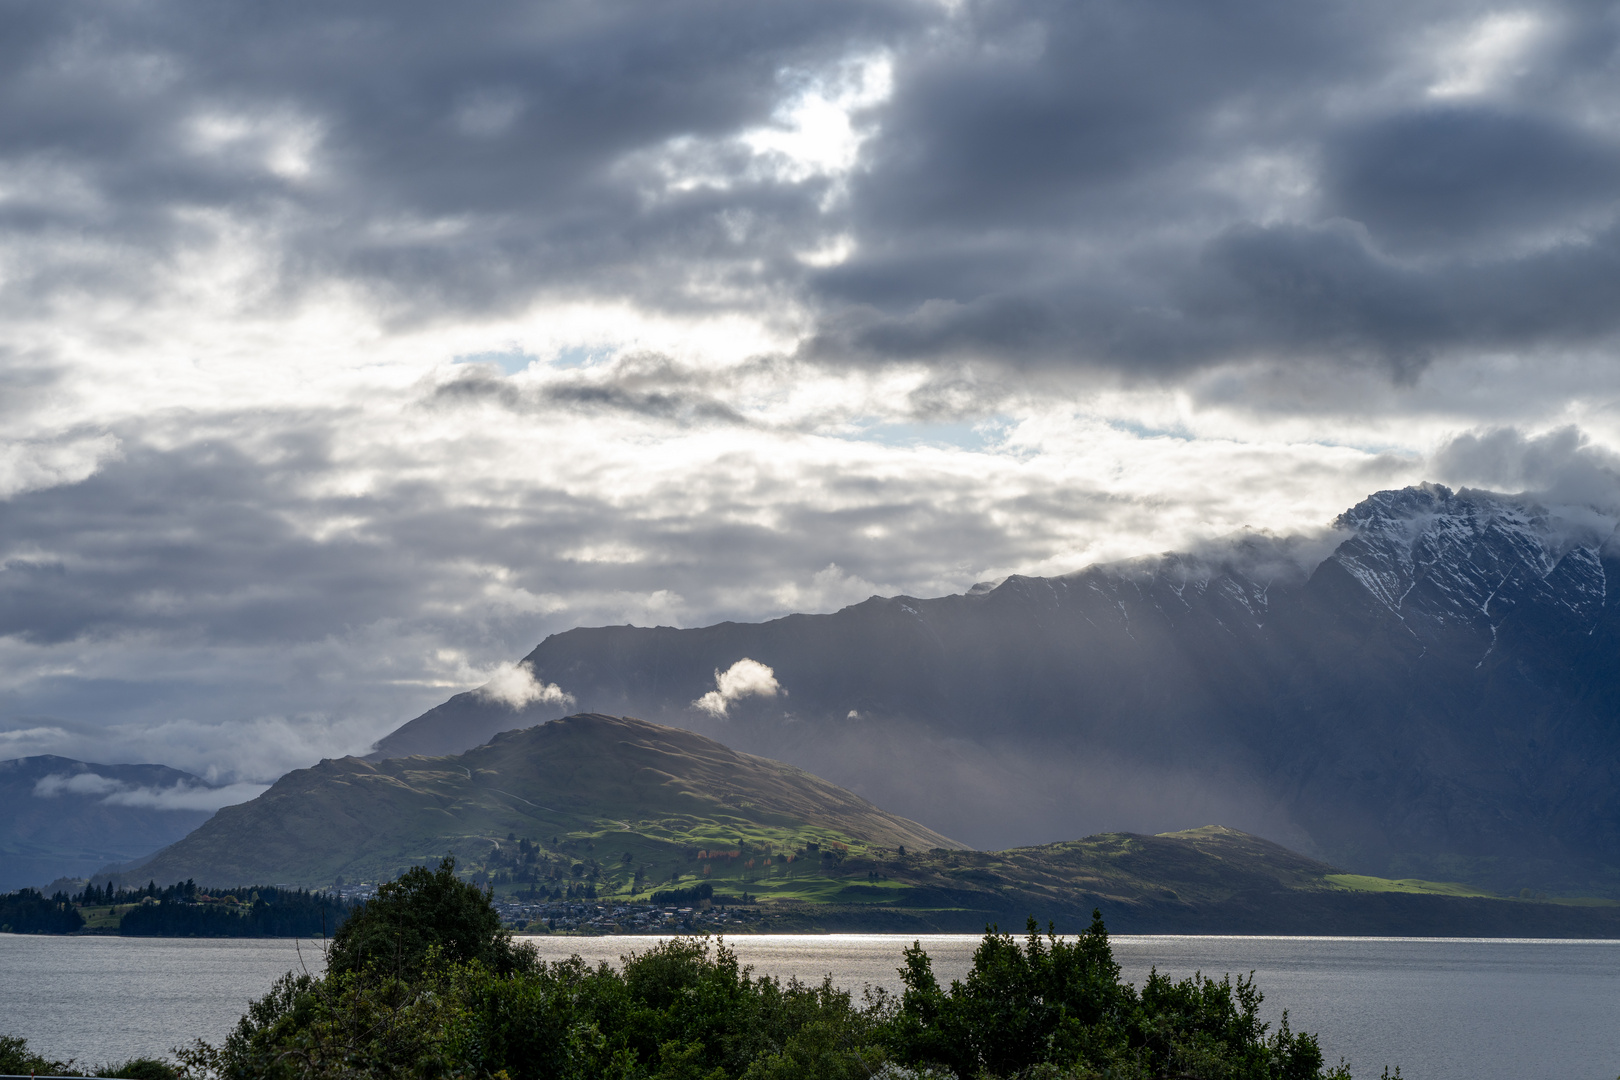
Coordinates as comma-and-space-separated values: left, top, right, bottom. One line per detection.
374, 484, 1620, 895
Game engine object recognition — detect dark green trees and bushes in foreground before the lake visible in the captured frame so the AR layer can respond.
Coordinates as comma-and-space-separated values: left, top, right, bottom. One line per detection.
161, 860, 1348, 1080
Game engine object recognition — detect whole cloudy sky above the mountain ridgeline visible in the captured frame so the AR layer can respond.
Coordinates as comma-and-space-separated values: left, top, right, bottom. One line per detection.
0, 0, 1620, 790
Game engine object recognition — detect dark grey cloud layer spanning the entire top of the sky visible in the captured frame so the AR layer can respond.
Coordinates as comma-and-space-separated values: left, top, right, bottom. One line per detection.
0, 0, 1620, 380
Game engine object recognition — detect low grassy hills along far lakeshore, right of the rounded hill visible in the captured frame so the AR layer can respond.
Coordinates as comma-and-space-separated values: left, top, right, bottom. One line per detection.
709, 826, 1620, 938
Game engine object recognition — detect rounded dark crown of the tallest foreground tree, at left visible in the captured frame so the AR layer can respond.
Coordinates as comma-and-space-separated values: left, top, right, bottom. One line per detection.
327, 857, 531, 976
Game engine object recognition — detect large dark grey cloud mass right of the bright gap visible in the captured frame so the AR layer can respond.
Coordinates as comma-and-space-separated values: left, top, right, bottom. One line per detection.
810, 3, 1620, 377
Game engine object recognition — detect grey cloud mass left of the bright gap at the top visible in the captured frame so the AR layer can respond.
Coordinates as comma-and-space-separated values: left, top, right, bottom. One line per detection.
0, 0, 915, 313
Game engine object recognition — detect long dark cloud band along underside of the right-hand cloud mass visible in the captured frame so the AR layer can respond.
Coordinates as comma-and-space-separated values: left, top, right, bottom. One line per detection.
812, 213, 1620, 375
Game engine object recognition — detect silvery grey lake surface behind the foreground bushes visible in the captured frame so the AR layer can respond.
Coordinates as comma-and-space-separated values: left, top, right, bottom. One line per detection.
0, 934, 1620, 1080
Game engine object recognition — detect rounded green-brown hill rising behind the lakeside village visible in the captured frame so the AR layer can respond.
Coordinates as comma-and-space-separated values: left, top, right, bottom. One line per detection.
128, 716, 961, 886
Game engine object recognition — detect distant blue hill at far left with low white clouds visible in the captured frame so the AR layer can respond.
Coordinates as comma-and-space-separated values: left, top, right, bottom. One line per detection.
0, 755, 214, 892
